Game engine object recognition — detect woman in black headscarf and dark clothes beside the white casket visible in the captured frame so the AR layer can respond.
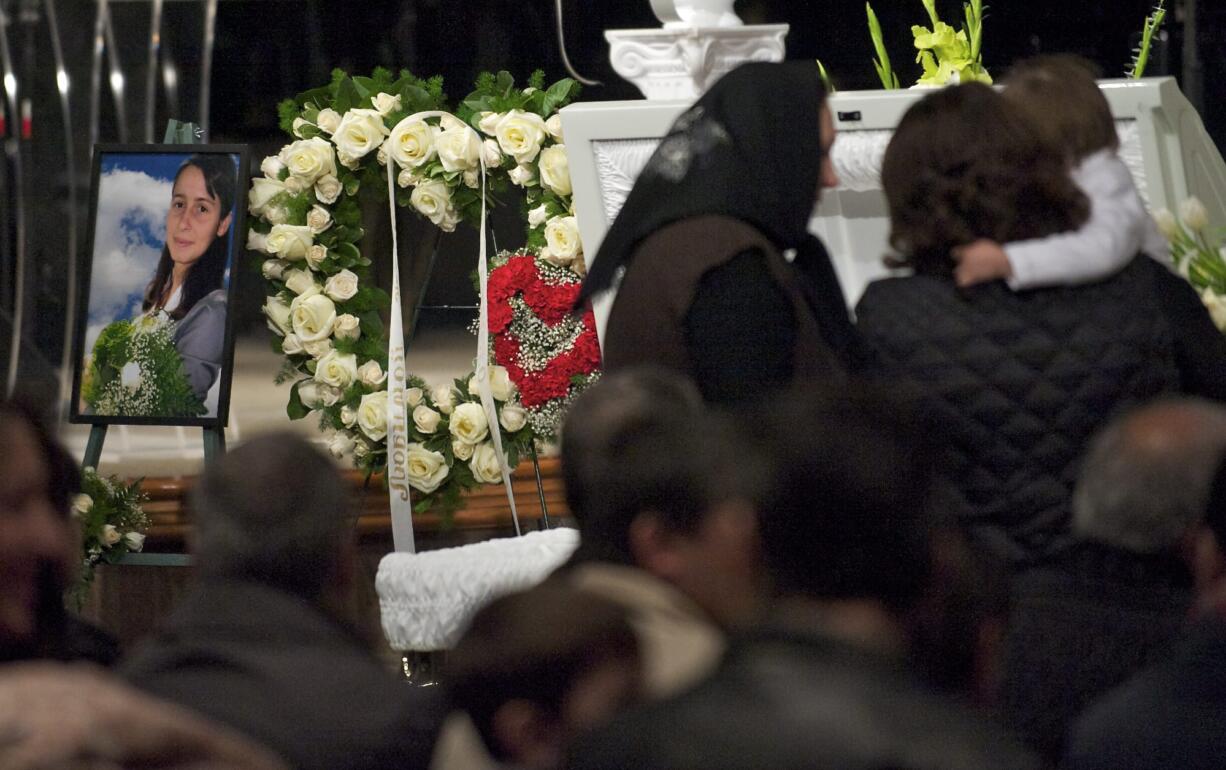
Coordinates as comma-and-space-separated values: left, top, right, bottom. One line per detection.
580, 61, 857, 405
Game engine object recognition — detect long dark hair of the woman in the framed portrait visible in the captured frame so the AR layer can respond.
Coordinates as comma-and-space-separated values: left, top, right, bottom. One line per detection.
141, 154, 238, 320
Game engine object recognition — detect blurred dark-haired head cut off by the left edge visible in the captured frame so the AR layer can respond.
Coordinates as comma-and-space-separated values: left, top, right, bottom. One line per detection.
0, 401, 81, 660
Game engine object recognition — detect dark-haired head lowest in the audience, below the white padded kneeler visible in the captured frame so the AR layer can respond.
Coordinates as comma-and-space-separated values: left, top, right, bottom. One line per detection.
445, 581, 640, 768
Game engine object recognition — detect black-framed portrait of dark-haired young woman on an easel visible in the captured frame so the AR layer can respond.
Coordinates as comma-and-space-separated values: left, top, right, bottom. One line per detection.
71, 145, 248, 427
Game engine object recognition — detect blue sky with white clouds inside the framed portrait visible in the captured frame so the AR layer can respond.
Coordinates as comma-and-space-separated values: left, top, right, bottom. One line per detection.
85, 152, 237, 354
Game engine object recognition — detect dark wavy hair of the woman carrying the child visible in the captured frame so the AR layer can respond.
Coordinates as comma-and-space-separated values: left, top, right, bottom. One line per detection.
881, 83, 1090, 275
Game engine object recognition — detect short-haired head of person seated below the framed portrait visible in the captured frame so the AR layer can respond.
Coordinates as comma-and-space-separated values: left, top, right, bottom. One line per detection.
191, 433, 349, 600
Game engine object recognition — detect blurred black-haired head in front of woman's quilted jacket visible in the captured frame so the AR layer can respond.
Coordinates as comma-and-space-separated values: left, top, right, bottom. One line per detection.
754, 386, 933, 611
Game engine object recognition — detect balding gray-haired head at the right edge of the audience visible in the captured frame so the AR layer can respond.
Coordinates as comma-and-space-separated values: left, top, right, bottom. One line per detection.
1073, 398, 1226, 554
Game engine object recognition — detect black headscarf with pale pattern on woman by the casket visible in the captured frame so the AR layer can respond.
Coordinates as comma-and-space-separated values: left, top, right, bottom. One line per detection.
579, 61, 855, 360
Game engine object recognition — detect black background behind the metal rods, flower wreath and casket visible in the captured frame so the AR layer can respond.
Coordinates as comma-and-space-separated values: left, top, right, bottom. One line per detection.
0, 0, 1226, 402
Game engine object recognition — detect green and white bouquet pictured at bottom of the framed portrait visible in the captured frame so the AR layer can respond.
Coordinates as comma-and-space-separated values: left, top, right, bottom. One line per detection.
81, 315, 205, 417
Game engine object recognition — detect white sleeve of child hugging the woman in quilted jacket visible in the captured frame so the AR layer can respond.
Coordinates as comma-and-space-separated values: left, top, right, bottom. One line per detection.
1004, 151, 1149, 289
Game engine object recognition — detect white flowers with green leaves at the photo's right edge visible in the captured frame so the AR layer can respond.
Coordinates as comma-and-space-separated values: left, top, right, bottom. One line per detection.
1154, 197, 1226, 332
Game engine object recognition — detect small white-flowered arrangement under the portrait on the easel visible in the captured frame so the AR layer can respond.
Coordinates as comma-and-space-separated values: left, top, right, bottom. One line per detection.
70, 468, 150, 607
